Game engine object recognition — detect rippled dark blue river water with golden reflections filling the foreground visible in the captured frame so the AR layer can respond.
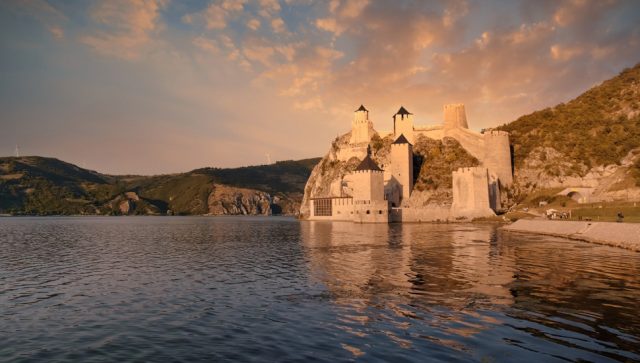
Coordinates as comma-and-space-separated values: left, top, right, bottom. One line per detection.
0, 217, 640, 362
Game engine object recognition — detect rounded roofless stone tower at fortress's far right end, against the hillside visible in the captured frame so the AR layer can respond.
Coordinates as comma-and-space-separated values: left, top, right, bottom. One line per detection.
483, 130, 513, 186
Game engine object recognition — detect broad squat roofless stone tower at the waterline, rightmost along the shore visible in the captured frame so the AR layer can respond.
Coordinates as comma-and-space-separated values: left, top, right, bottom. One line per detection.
451, 166, 495, 218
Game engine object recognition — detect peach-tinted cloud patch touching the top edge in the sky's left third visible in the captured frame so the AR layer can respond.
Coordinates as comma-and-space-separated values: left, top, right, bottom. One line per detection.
80, 0, 166, 60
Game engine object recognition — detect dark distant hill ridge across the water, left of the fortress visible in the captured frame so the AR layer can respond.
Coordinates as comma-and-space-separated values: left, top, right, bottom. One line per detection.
0, 156, 319, 215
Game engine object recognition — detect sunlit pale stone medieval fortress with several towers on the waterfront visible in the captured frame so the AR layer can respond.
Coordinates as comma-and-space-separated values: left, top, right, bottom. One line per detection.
301, 104, 513, 223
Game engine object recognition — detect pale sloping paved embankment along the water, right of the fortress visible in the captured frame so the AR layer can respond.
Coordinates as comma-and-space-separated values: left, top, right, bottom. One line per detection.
501, 219, 640, 252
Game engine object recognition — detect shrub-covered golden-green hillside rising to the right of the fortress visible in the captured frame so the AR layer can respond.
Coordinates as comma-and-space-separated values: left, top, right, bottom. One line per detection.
498, 64, 640, 175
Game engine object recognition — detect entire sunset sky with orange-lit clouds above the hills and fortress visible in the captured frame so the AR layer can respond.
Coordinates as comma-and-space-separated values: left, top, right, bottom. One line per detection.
0, 0, 640, 174
